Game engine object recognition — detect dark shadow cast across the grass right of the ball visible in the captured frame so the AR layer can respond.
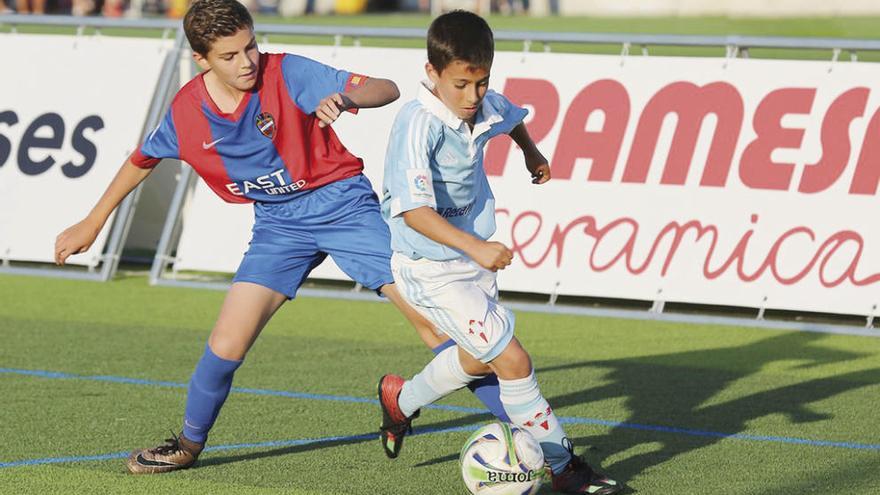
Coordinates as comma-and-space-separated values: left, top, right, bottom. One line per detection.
417, 332, 880, 490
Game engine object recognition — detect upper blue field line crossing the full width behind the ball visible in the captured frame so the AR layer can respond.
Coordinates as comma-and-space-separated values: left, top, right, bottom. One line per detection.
0, 368, 880, 458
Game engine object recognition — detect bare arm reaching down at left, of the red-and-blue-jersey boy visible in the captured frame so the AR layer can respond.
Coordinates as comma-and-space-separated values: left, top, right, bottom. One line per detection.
55, 160, 153, 265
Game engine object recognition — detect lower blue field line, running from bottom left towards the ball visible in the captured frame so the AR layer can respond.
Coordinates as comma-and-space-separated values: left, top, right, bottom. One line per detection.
0, 425, 482, 469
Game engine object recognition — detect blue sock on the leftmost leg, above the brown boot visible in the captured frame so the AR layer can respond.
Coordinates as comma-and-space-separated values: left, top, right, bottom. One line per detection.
183, 345, 241, 444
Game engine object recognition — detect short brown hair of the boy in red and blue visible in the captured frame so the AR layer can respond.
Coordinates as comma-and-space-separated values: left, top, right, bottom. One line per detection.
183, 0, 254, 56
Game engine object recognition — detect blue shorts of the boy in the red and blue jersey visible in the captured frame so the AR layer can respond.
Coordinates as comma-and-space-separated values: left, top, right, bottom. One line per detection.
233, 174, 394, 299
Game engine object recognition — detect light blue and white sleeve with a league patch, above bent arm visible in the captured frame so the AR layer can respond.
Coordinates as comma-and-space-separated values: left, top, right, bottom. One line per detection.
385, 109, 442, 217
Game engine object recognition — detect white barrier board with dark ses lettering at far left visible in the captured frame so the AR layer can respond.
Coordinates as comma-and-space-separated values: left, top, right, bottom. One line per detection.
0, 34, 173, 266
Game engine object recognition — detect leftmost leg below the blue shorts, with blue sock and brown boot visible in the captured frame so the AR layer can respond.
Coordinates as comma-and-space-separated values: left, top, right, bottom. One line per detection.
126, 282, 287, 474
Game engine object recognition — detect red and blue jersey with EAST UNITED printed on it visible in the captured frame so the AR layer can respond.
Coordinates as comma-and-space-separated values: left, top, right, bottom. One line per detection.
131, 53, 367, 203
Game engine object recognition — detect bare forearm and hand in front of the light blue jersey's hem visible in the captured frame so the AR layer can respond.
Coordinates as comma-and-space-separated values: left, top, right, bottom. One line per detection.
403, 206, 513, 272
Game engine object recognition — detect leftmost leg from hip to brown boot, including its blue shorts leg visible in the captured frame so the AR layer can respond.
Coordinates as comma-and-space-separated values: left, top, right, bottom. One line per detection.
127, 200, 325, 473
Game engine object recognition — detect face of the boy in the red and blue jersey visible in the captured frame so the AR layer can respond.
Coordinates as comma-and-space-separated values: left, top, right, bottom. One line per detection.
193, 28, 260, 91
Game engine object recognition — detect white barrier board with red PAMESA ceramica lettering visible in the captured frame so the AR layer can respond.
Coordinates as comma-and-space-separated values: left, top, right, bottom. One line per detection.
178, 46, 880, 315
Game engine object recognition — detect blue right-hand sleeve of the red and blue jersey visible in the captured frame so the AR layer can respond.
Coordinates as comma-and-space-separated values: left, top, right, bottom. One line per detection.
281, 53, 368, 114
